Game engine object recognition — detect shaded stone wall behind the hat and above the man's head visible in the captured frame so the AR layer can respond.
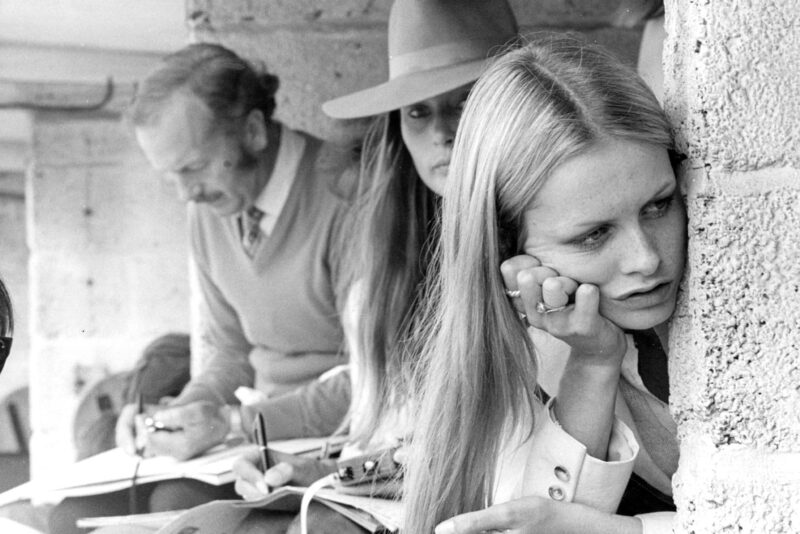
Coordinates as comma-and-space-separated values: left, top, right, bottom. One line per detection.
187, 0, 641, 140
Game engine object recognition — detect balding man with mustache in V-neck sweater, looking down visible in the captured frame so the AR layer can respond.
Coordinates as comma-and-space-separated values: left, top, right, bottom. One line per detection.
117, 44, 352, 459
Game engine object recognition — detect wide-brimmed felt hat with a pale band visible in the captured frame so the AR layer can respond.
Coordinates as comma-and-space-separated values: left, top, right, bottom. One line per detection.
322, 0, 517, 119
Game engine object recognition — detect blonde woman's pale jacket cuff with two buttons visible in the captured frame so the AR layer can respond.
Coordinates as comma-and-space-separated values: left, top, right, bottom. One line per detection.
523, 399, 639, 513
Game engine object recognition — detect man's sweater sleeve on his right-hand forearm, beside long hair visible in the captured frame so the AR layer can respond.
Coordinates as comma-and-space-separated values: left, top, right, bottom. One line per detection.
242, 365, 350, 439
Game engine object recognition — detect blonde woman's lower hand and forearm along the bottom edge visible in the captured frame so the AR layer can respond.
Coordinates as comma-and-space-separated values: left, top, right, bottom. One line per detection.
436, 497, 642, 534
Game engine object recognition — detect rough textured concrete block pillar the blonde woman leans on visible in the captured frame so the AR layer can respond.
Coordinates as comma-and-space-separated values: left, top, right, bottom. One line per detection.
664, 0, 800, 533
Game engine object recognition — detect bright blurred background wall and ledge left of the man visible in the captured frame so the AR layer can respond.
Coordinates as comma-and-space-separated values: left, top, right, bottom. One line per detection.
0, 0, 188, 478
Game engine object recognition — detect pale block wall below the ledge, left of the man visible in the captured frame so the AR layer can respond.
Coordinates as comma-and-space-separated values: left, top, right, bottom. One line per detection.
27, 112, 189, 476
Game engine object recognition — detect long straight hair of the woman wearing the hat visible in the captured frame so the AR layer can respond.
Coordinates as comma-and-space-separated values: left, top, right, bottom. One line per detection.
340, 110, 439, 446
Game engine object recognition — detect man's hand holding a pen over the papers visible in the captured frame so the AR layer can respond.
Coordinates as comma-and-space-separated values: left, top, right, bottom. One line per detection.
116, 401, 230, 460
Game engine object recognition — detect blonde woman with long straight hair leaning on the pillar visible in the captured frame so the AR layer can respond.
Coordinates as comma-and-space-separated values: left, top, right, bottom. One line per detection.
405, 37, 686, 534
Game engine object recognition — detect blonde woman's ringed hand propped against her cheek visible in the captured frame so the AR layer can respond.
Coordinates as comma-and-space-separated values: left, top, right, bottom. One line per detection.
500, 255, 626, 363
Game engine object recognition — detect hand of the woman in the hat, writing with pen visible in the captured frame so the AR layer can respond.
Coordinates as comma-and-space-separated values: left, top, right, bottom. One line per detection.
233, 450, 336, 501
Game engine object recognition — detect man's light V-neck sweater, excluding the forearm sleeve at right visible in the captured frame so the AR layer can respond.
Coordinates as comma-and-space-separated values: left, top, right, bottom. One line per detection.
179, 130, 352, 404
